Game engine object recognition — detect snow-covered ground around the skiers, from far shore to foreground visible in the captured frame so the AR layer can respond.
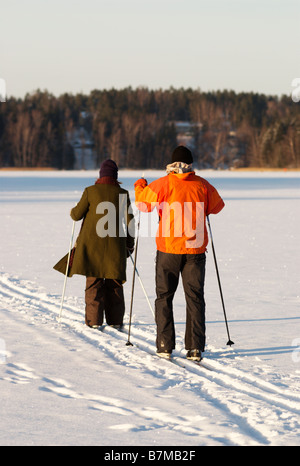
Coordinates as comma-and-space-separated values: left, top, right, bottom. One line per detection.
0, 171, 300, 448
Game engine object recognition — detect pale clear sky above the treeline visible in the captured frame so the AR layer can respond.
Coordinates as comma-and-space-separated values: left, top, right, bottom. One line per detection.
0, 0, 300, 97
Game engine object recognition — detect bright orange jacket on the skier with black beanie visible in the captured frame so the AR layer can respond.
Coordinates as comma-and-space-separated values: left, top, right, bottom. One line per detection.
134, 172, 225, 254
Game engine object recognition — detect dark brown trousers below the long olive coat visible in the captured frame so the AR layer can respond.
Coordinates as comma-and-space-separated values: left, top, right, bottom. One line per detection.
85, 277, 125, 327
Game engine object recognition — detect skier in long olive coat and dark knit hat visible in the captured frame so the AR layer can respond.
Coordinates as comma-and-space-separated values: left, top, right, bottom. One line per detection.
54, 160, 135, 328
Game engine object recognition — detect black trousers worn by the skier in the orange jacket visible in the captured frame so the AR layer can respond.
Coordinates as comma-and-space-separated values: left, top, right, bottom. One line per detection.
155, 251, 206, 351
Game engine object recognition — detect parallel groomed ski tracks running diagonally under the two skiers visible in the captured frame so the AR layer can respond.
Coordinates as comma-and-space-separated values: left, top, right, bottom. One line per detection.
0, 275, 300, 445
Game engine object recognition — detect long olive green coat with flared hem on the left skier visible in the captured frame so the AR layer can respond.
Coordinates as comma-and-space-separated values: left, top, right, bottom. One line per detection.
54, 184, 134, 283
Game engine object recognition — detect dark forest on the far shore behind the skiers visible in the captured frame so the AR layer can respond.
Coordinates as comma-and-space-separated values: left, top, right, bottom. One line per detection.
0, 88, 300, 169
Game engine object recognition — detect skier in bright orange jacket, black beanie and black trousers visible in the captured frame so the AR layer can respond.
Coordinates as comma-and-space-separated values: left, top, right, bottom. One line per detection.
134, 146, 225, 361
